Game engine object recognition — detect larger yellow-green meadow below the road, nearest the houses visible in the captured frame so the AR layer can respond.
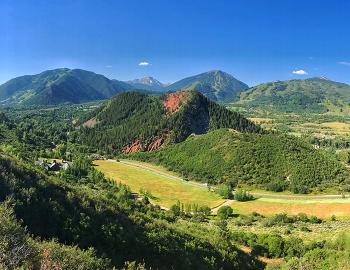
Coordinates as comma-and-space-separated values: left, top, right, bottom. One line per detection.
94, 160, 225, 208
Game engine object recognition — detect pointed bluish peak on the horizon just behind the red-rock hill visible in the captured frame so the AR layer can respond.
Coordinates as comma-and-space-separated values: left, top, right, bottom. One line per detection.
165, 70, 248, 102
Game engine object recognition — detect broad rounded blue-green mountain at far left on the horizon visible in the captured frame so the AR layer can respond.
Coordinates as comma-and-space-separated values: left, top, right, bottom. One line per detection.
0, 68, 132, 105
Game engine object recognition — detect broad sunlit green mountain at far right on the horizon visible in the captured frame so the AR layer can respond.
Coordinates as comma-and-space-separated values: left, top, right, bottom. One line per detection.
238, 78, 350, 113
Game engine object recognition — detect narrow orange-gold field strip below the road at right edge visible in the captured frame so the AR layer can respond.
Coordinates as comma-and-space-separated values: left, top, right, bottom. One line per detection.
231, 198, 350, 218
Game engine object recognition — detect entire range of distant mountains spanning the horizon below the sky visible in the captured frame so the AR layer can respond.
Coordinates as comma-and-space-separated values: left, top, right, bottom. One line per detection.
0, 68, 350, 114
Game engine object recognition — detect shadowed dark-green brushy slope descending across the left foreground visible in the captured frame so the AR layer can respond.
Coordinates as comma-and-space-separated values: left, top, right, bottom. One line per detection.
0, 156, 261, 269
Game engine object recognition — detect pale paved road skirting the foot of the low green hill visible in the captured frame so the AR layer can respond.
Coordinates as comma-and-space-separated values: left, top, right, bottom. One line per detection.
109, 159, 350, 200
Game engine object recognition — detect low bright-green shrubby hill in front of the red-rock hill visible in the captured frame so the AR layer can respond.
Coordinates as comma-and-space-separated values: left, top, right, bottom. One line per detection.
132, 129, 349, 193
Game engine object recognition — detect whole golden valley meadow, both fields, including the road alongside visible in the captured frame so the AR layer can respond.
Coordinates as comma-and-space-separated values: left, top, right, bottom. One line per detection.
94, 160, 350, 219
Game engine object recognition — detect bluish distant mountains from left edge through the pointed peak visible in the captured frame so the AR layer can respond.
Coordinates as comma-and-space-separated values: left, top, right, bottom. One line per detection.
0, 68, 248, 106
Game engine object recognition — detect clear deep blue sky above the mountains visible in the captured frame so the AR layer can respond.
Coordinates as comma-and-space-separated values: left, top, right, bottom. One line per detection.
0, 0, 350, 85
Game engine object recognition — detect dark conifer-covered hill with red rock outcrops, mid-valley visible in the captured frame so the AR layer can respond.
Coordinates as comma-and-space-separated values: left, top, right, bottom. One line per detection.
79, 91, 261, 153
